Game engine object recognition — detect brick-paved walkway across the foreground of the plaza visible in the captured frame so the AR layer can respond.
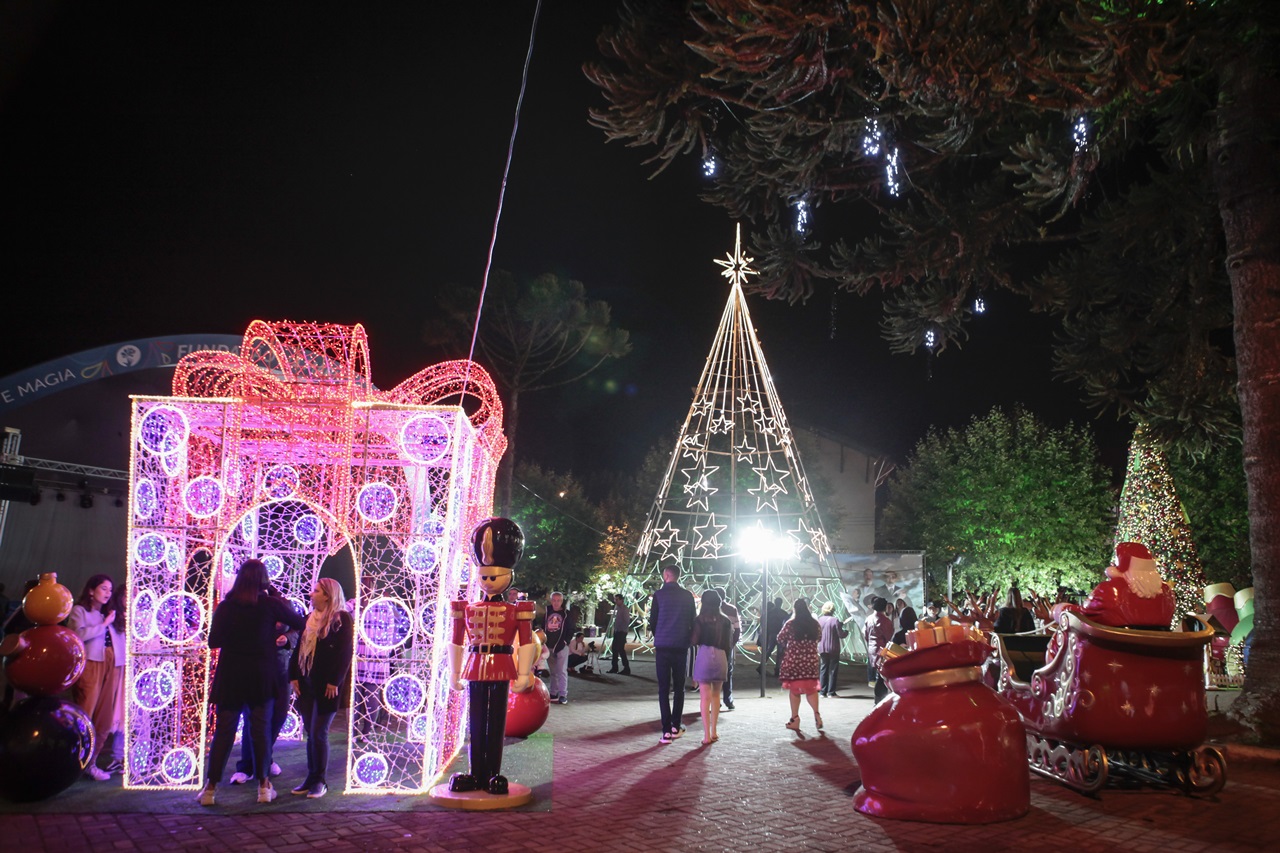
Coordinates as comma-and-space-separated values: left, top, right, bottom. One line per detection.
0, 658, 1280, 853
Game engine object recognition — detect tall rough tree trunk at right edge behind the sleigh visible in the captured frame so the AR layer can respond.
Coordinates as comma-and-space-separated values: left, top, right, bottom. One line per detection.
1210, 53, 1280, 744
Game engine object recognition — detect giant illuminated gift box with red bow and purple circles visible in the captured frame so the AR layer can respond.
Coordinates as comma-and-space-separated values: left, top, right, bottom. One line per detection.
124, 321, 507, 793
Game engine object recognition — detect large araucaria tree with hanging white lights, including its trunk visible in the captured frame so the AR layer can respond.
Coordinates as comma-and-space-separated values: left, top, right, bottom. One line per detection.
586, 0, 1280, 742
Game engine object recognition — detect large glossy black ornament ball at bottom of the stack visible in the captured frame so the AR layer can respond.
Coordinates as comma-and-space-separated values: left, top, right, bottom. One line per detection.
0, 697, 93, 803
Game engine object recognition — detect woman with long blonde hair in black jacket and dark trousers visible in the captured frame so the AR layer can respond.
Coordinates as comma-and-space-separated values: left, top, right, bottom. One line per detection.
289, 578, 356, 799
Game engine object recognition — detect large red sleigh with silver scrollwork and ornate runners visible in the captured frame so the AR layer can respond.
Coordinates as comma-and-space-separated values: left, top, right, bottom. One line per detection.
997, 612, 1226, 795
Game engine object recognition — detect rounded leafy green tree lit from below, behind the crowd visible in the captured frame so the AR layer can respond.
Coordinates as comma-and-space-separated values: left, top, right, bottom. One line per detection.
877, 409, 1115, 596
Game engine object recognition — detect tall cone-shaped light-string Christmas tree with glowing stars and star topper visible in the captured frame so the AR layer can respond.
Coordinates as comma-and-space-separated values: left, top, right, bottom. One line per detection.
632, 225, 849, 642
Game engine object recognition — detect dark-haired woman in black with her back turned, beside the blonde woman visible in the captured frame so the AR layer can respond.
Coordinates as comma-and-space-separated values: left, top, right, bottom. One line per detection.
200, 560, 305, 806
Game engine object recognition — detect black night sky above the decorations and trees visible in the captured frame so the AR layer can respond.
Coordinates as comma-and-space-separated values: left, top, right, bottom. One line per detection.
0, 0, 1128, 484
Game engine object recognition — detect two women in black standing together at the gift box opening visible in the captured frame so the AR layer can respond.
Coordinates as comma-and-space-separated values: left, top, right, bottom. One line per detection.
198, 560, 355, 806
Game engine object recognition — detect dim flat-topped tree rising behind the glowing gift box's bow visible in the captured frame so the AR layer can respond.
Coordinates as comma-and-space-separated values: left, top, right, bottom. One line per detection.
425, 270, 631, 514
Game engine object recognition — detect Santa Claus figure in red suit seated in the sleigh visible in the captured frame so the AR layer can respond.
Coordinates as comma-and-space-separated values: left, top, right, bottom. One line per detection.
1053, 542, 1175, 630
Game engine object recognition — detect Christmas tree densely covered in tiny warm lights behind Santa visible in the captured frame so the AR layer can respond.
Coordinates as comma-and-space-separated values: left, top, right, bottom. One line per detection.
1116, 425, 1207, 622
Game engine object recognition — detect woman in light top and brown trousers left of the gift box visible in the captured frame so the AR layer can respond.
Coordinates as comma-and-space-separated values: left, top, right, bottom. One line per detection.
67, 575, 124, 781
